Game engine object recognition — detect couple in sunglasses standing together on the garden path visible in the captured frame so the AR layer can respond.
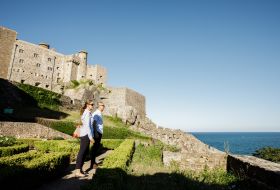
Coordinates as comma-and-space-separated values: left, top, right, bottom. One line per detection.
75, 100, 105, 177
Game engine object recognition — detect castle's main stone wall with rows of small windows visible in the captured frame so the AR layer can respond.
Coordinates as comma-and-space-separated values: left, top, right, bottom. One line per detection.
10, 40, 64, 90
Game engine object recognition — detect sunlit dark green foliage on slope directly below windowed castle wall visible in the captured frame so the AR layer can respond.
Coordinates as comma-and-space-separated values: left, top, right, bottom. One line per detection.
17, 83, 61, 110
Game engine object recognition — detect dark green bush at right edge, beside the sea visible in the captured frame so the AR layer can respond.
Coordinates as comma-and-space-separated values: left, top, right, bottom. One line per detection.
253, 147, 280, 163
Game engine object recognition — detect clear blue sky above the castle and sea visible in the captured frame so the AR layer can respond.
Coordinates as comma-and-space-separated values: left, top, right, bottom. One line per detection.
0, 0, 280, 131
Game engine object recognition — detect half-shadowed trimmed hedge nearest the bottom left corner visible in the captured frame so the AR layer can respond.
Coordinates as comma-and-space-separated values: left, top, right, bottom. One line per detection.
0, 151, 70, 189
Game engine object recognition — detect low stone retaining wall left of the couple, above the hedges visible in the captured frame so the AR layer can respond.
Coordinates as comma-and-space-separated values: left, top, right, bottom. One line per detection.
0, 122, 72, 139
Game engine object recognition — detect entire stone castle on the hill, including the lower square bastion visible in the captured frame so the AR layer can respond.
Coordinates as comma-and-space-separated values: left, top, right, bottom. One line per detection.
0, 26, 146, 120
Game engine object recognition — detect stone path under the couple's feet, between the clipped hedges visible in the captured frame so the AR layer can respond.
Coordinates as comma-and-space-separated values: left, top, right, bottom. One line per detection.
37, 150, 110, 190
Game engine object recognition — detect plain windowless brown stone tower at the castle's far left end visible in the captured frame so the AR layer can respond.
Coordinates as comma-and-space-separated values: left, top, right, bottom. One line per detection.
0, 26, 17, 79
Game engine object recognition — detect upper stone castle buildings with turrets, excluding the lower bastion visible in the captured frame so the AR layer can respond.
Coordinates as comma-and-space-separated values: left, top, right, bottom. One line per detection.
0, 27, 107, 93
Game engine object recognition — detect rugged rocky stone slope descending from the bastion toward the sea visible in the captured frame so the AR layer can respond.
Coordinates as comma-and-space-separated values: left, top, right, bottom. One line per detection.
131, 117, 227, 171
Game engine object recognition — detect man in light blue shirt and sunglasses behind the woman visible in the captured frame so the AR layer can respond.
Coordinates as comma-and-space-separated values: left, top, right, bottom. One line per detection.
89, 102, 105, 170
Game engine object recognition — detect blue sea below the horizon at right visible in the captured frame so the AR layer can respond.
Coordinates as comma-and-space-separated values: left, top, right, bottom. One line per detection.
191, 132, 280, 155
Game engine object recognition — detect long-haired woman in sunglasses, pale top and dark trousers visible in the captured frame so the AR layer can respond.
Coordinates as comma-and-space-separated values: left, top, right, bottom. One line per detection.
75, 100, 94, 177
